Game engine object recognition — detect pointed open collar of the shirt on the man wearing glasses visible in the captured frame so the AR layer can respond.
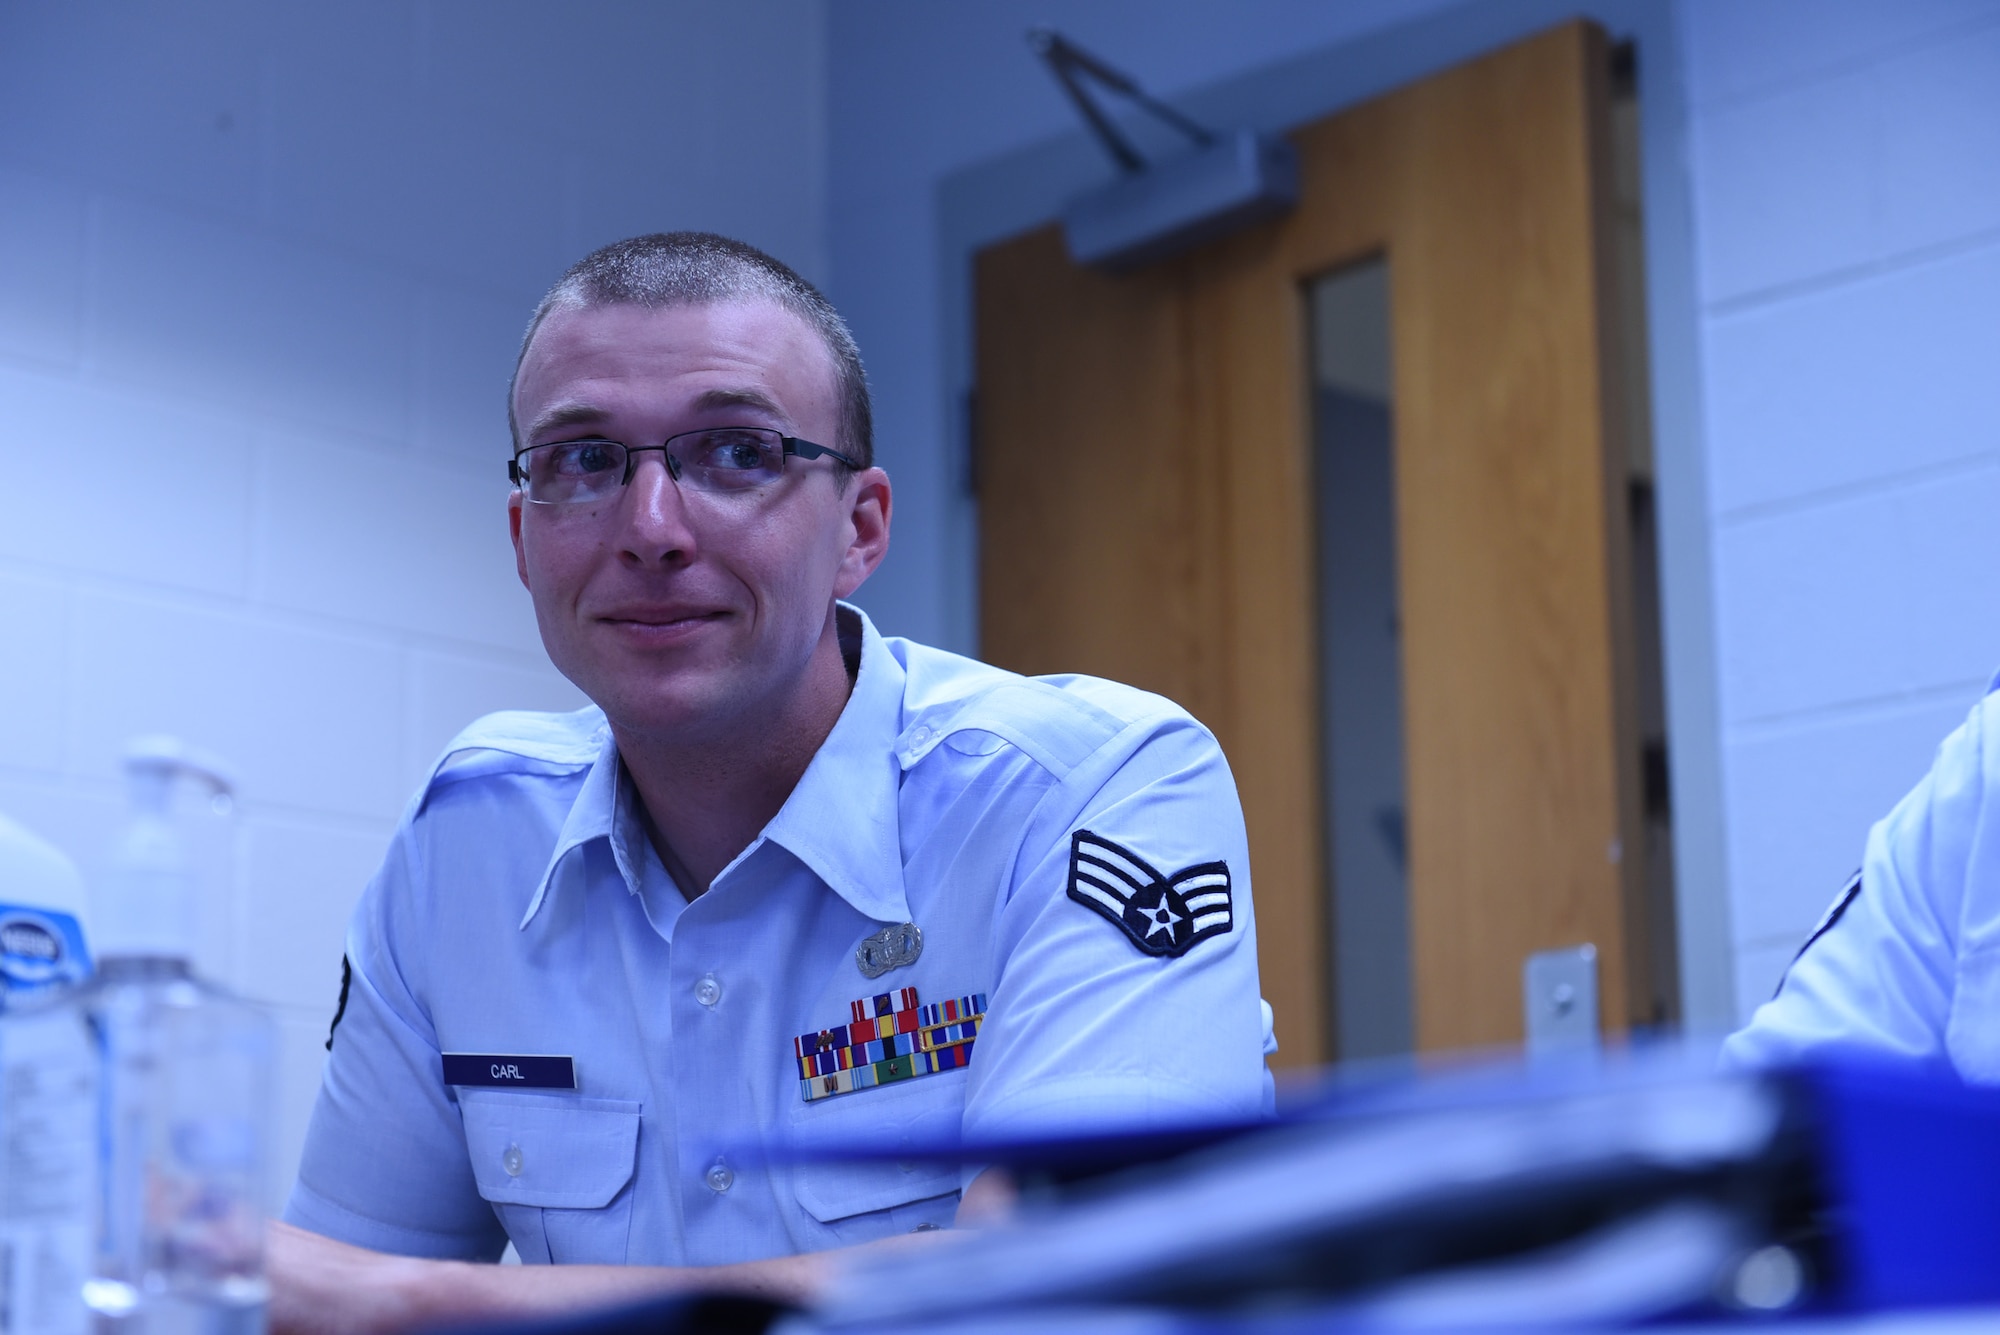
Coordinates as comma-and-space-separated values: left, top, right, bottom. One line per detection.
520, 604, 910, 927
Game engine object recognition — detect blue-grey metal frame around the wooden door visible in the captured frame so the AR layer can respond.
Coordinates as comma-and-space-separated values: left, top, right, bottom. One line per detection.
936, 0, 1736, 1031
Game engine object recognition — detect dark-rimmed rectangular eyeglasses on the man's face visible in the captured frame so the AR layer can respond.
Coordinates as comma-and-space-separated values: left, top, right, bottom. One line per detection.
506, 426, 862, 506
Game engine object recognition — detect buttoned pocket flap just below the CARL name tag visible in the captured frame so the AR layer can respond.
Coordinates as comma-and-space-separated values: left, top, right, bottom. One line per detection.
458, 1089, 638, 1209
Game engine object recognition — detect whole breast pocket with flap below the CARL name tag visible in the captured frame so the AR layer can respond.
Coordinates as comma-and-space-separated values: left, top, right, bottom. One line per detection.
458, 1089, 640, 1265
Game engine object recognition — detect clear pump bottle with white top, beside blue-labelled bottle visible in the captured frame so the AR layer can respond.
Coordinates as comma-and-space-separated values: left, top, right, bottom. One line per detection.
74, 737, 276, 1335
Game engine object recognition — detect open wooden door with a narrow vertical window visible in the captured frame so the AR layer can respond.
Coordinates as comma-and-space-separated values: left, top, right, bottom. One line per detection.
976, 22, 1650, 1063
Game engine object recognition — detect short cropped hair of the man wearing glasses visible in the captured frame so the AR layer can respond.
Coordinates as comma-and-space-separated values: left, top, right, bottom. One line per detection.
506, 232, 874, 468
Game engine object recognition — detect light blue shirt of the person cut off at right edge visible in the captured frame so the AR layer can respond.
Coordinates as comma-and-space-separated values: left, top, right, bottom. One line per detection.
1724, 679, 2000, 1083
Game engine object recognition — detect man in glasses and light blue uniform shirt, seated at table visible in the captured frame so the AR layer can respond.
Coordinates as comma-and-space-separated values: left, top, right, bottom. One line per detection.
274, 234, 1270, 1329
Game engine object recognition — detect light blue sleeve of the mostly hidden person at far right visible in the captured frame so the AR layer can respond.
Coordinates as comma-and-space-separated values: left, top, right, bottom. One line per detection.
1722, 703, 1990, 1067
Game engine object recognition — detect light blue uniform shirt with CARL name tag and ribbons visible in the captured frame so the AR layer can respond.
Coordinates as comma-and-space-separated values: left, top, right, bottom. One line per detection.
286, 608, 1270, 1265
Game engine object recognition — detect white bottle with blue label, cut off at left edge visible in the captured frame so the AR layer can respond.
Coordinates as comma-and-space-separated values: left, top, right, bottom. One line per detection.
0, 817, 98, 1335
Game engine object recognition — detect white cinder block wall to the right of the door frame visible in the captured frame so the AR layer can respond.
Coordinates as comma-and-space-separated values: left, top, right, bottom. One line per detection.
1686, 0, 2000, 1013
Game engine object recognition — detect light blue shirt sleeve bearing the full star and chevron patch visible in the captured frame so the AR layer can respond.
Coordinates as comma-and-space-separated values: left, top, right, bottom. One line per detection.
964, 715, 1272, 1137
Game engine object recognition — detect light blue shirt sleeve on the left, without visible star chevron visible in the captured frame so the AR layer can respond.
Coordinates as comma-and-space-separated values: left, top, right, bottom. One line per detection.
284, 807, 506, 1261
